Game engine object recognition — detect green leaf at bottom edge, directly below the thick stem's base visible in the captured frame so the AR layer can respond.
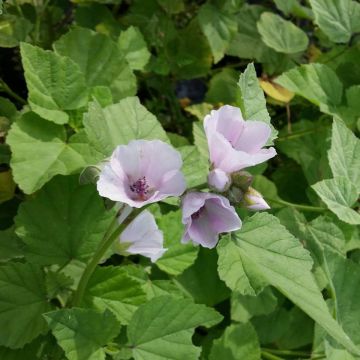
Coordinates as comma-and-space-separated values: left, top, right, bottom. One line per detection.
44, 308, 120, 360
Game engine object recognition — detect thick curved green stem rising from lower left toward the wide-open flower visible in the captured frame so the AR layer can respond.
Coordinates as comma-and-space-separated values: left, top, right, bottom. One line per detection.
73, 208, 134, 306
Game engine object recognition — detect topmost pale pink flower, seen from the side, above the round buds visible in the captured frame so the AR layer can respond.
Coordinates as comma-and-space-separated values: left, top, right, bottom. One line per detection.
204, 105, 276, 174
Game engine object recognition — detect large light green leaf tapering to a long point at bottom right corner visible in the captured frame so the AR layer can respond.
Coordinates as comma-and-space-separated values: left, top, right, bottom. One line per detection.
220, 213, 360, 354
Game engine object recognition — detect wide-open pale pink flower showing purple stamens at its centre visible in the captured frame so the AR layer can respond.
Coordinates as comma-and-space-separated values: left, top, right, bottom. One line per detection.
97, 140, 186, 208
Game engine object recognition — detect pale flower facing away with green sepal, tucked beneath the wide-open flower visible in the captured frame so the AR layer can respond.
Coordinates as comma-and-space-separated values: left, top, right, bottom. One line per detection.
115, 210, 167, 262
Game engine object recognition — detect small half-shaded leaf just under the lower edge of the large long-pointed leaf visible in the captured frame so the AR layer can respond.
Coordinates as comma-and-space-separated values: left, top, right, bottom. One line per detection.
231, 287, 277, 322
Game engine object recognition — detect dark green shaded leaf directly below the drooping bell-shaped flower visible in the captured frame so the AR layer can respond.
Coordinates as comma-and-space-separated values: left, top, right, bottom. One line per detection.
175, 248, 230, 306
